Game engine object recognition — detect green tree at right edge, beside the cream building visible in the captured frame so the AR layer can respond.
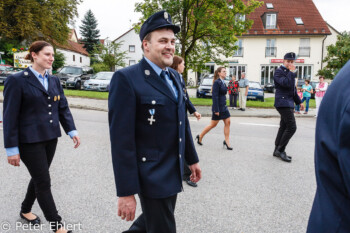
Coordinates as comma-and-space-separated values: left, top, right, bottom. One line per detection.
317, 32, 350, 79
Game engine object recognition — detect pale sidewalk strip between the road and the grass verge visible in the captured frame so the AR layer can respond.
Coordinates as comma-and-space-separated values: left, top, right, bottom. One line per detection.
0, 92, 315, 118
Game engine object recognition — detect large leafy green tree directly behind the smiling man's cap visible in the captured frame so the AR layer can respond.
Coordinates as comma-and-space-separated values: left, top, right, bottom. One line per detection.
135, 0, 263, 79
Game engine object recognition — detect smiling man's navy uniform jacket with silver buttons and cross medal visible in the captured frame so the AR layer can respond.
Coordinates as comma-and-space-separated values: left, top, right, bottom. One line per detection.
108, 59, 198, 198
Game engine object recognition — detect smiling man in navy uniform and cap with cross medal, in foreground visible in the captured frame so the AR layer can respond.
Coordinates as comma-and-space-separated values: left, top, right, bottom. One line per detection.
108, 11, 201, 233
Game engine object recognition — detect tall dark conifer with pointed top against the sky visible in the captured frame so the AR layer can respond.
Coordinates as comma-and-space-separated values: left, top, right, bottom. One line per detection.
80, 10, 100, 53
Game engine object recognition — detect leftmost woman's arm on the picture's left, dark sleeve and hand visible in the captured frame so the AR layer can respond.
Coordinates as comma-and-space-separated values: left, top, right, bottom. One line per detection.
3, 76, 22, 166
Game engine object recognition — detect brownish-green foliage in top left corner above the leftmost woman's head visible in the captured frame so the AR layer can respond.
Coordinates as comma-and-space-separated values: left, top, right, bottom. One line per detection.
0, 0, 81, 44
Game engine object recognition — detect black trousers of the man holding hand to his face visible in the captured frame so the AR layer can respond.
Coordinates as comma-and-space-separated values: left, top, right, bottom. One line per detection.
275, 107, 297, 152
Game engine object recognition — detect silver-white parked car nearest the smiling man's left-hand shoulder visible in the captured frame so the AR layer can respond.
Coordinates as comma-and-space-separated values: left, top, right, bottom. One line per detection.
84, 72, 114, 91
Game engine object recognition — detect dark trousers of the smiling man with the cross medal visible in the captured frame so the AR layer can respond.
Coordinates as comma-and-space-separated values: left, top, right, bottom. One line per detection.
123, 194, 177, 233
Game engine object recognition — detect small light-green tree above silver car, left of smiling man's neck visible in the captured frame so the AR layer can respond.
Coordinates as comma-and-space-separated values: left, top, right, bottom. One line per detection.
93, 42, 127, 71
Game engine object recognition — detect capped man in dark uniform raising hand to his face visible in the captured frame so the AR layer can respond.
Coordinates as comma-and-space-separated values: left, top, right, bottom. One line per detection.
273, 53, 301, 162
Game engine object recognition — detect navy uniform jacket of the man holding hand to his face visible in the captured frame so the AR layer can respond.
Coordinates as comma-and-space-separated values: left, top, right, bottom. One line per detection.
273, 66, 301, 108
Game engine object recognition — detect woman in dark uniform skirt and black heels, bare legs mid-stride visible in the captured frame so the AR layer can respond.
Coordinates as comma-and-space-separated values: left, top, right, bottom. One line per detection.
196, 67, 232, 150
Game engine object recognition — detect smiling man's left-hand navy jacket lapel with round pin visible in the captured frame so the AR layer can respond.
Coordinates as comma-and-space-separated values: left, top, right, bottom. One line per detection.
141, 59, 177, 102
